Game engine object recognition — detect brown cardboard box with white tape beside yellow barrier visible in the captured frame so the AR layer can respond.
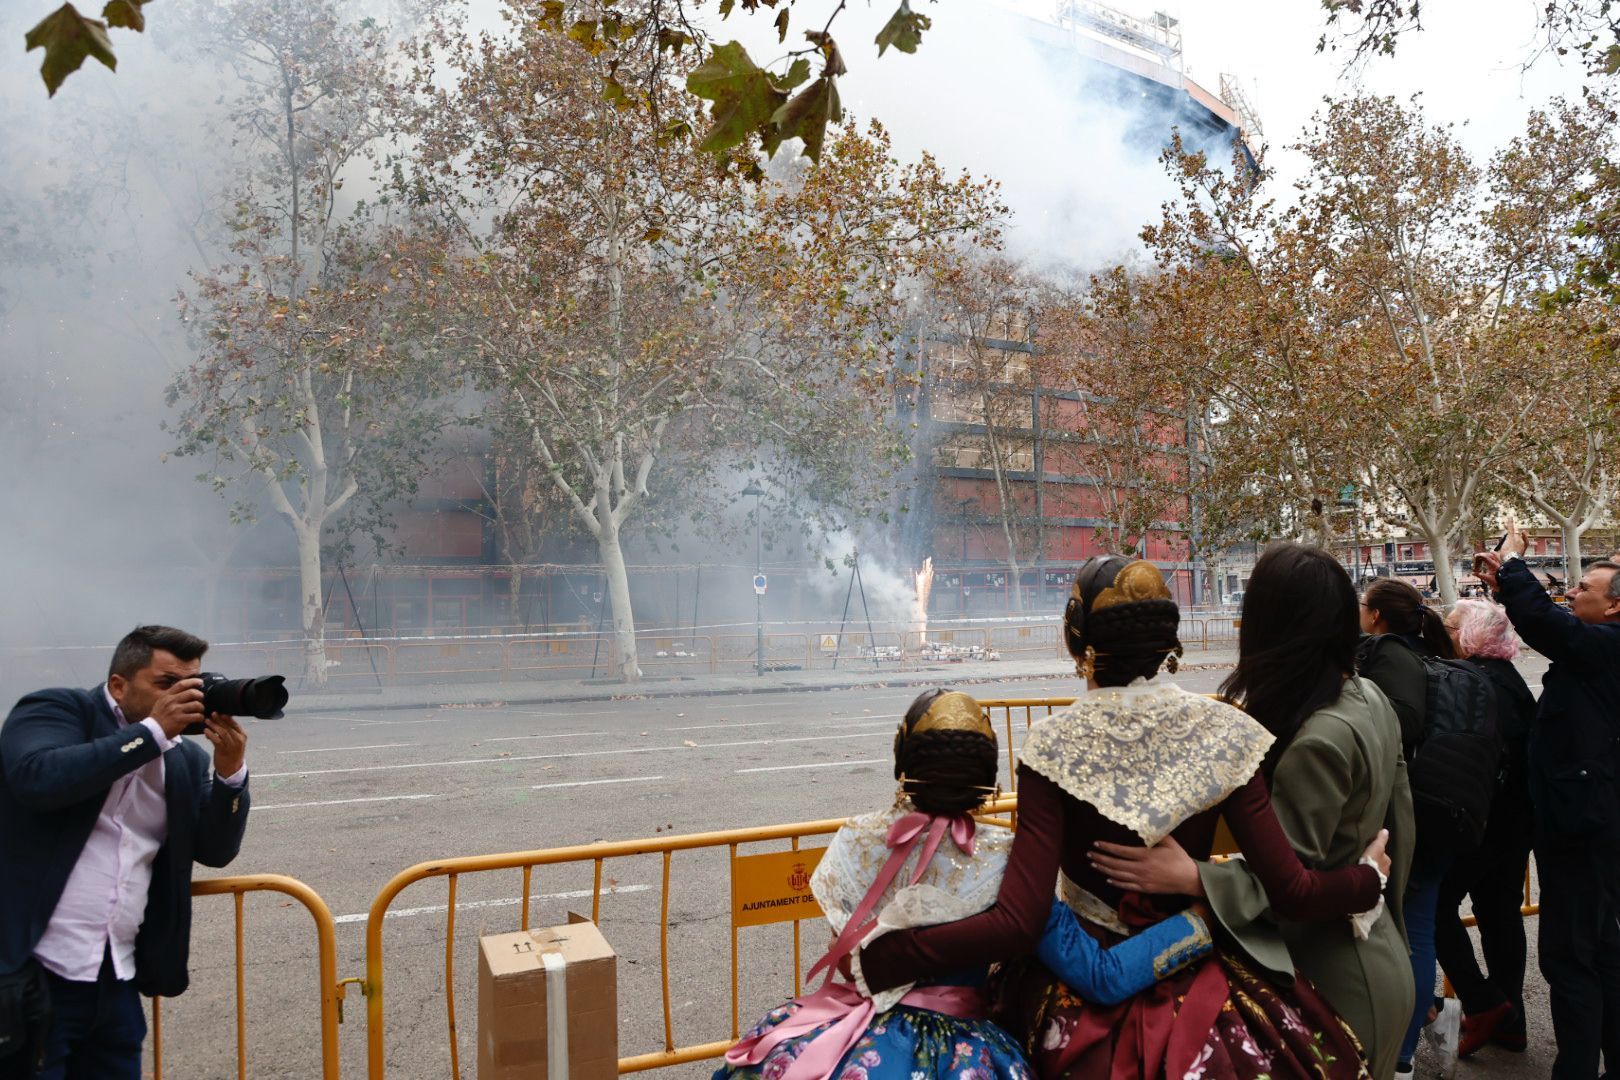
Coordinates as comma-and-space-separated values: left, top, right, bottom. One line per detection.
478, 915, 619, 1080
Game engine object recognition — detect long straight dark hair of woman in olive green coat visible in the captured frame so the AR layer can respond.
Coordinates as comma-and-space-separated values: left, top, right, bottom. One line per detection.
1220, 544, 1361, 772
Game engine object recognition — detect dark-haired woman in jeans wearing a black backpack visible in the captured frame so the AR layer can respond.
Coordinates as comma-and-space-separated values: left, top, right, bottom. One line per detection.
1356, 578, 1502, 1078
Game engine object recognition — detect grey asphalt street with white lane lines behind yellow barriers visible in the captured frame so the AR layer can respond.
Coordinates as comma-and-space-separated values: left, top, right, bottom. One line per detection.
152, 659, 1552, 1078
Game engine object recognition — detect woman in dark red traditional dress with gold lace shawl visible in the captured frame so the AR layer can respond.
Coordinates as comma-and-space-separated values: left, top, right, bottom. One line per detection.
859, 557, 1390, 1080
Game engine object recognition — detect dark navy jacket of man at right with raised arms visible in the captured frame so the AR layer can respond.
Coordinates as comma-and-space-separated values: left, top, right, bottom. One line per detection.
1497, 559, 1620, 845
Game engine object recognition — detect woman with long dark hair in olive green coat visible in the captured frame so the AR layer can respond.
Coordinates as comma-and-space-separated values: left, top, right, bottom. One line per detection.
1095, 544, 1416, 1080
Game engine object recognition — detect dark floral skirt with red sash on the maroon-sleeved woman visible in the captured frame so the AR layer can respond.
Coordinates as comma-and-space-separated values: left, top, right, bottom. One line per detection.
996, 949, 1369, 1080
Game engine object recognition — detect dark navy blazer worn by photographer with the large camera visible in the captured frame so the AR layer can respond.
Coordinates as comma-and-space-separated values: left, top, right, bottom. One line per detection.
0, 687, 248, 997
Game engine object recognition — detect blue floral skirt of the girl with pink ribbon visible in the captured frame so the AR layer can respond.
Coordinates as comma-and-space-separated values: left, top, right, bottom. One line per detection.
714, 1002, 1032, 1080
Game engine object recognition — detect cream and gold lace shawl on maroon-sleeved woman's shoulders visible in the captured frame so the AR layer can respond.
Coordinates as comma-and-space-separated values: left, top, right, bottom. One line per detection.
1019, 680, 1272, 845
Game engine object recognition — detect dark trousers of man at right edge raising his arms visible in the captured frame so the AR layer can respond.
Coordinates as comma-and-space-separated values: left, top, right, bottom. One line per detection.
1536, 844, 1620, 1080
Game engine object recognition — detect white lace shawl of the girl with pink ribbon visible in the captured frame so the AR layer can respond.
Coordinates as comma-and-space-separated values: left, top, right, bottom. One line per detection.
810, 803, 1013, 1012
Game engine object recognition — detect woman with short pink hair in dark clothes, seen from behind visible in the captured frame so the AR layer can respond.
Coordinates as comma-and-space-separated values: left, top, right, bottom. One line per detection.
1434, 601, 1536, 1057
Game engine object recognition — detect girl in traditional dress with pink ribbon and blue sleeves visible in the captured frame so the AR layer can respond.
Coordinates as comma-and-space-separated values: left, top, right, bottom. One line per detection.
714, 690, 1210, 1080
